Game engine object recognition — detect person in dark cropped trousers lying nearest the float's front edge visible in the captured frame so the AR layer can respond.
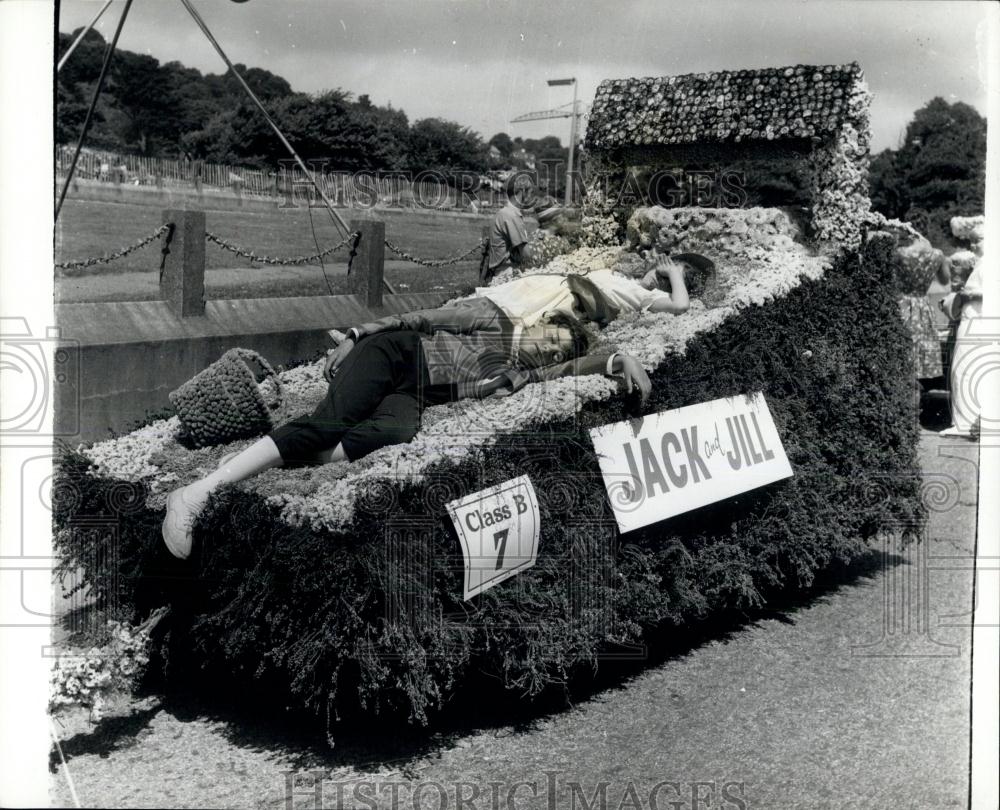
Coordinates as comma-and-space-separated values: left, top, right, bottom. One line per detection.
162, 306, 651, 559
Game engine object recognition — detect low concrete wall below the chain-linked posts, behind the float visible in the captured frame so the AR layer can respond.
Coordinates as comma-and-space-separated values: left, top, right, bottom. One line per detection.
54, 293, 450, 444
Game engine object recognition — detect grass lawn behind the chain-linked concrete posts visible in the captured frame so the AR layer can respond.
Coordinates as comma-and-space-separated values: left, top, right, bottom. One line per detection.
56, 199, 489, 301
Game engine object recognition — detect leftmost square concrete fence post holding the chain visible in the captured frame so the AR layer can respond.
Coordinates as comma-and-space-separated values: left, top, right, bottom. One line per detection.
160, 209, 205, 318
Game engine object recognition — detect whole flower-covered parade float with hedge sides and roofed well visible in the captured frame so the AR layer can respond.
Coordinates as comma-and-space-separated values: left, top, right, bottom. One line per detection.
54, 65, 922, 723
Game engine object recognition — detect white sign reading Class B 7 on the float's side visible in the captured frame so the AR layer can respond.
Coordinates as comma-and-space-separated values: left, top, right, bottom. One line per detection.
446, 475, 541, 599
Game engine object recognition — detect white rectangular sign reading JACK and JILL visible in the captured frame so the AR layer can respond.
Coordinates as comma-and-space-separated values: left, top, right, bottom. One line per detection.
590, 393, 792, 532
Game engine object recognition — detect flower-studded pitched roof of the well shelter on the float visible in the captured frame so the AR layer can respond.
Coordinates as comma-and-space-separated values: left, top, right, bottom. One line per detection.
585, 62, 864, 150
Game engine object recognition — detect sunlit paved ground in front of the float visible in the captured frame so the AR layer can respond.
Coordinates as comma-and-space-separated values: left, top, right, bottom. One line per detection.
52, 426, 978, 810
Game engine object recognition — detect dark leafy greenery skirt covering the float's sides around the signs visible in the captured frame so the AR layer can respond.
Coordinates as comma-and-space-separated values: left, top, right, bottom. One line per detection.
55, 232, 923, 724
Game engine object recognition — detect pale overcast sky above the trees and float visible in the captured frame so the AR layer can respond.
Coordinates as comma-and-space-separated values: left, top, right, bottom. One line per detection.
59, 0, 988, 150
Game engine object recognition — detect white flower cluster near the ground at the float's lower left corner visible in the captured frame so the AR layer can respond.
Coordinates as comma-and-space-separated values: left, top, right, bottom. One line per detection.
49, 622, 149, 722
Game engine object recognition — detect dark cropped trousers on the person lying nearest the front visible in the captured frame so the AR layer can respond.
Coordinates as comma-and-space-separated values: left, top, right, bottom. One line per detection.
270, 331, 448, 463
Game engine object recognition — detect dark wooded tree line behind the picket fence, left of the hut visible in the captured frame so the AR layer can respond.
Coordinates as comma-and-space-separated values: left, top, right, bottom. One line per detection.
55, 29, 566, 181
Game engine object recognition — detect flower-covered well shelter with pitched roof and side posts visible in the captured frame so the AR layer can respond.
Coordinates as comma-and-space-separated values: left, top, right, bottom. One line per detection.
585, 62, 871, 252
